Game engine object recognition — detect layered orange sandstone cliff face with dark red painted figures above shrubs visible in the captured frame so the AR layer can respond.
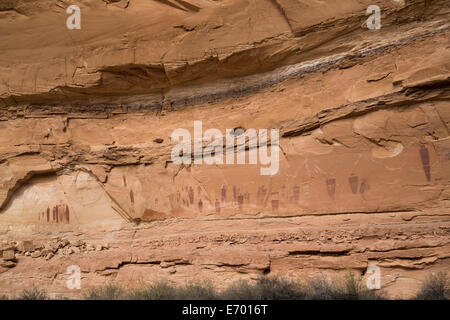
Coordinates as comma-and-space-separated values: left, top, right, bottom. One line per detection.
0, 0, 450, 297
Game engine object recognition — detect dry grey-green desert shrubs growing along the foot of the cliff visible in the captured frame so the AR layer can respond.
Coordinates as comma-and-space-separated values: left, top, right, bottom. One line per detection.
0, 272, 450, 300
